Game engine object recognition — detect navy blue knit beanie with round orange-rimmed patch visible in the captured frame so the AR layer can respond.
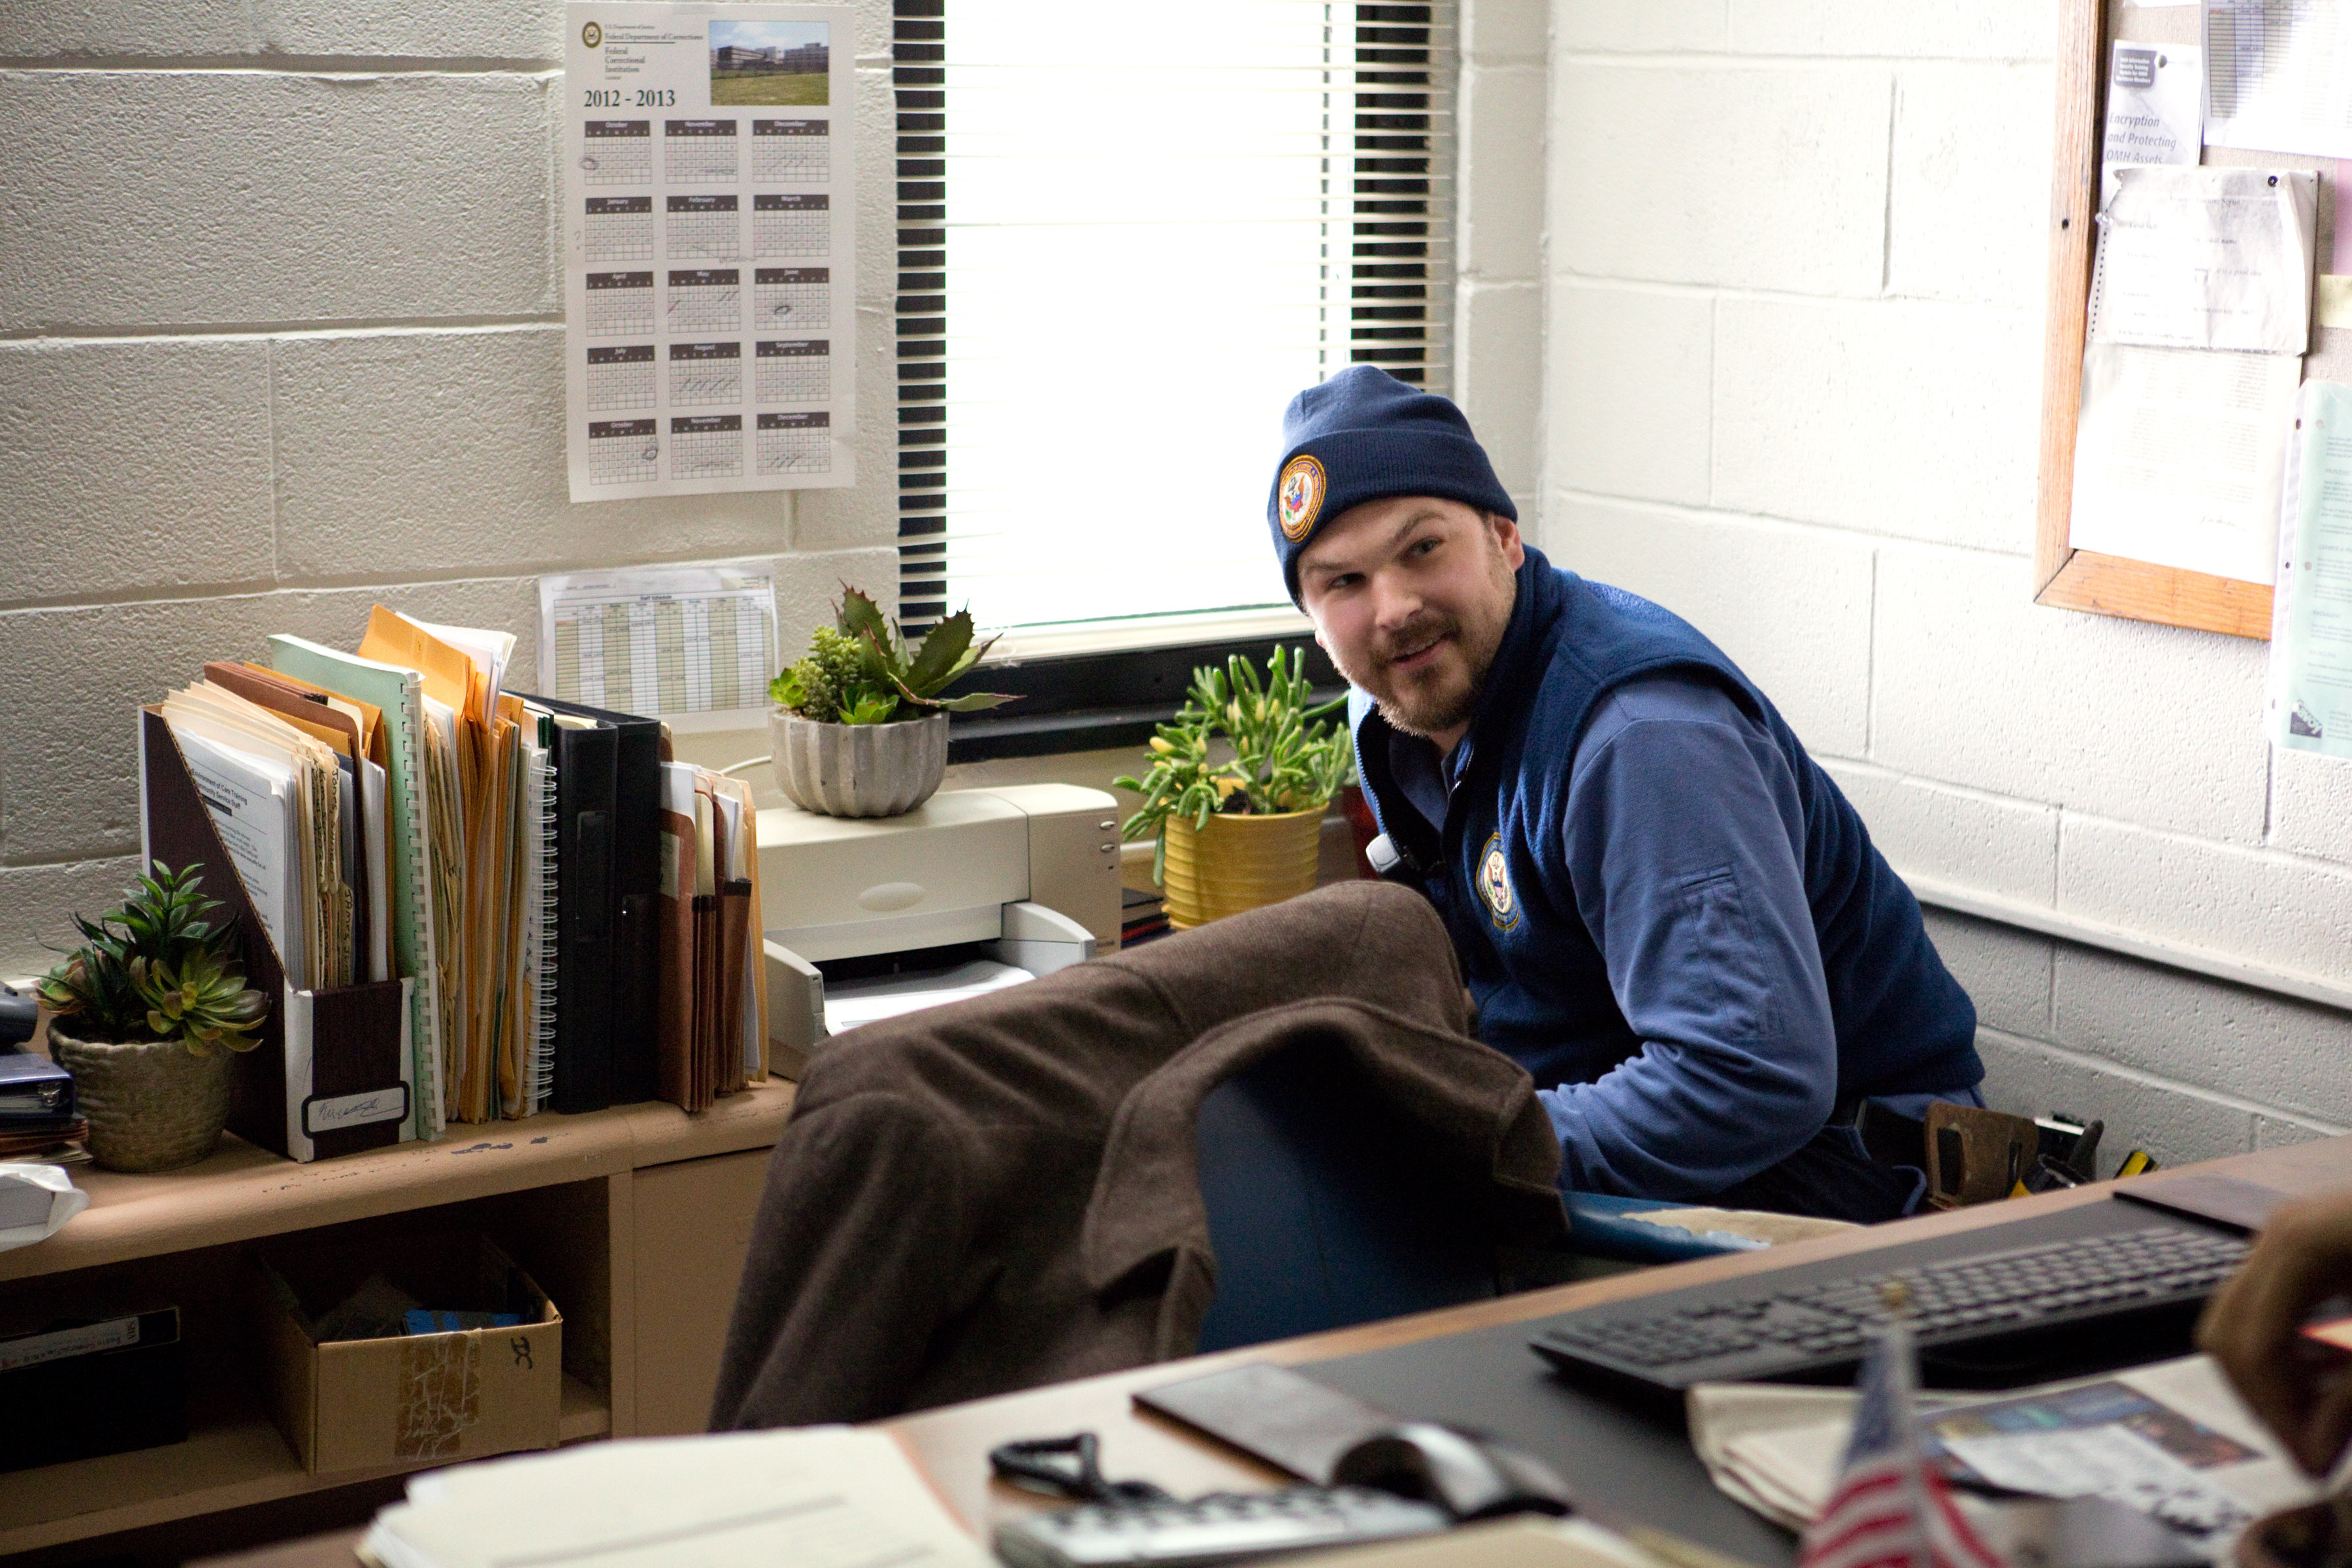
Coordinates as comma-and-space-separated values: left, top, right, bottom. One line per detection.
1266, 365, 1520, 604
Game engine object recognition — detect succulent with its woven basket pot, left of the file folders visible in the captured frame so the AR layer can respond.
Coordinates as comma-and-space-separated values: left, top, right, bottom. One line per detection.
40, 860, 270, 1171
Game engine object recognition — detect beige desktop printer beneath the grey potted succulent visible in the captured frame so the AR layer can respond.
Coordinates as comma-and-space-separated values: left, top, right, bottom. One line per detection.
757, 785, 1120, 1077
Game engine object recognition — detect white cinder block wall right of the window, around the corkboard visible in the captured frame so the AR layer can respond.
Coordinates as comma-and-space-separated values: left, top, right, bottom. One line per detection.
1533, 0, 2352, 1162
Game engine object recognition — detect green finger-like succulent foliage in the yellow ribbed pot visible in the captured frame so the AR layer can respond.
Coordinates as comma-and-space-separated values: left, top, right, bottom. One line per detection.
1110, 649, 1355, 881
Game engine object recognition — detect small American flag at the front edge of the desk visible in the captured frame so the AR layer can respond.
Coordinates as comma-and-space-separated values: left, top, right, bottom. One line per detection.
1797, 1316, 2004, 1568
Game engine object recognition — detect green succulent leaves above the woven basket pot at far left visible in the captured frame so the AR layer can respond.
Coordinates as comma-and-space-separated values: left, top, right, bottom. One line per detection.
40, 860, 270, 1056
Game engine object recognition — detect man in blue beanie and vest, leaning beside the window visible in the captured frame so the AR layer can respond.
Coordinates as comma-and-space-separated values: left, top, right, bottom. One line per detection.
1266, 365, 1985, 1222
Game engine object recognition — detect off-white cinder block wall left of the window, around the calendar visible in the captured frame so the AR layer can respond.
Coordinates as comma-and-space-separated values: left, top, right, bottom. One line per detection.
0, 0, 896, 975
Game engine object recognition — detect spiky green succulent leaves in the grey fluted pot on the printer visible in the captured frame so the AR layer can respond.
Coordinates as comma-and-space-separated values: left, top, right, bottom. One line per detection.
767, 583, 1014, 724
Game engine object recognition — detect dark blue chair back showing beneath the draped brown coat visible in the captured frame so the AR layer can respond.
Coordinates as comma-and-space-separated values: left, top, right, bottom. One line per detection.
1195, 1041, 1498, 1352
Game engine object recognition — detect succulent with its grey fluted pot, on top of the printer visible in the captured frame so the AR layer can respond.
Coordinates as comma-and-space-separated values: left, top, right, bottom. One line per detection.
767, 583, 1011, 816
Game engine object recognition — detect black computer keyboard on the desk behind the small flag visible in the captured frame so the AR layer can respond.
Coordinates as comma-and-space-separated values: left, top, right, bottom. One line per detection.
1531, 1225, 2246, 1392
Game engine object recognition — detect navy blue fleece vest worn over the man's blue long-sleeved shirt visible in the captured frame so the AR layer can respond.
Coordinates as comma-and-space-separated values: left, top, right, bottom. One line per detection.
1350, 550, 1983, 1114
